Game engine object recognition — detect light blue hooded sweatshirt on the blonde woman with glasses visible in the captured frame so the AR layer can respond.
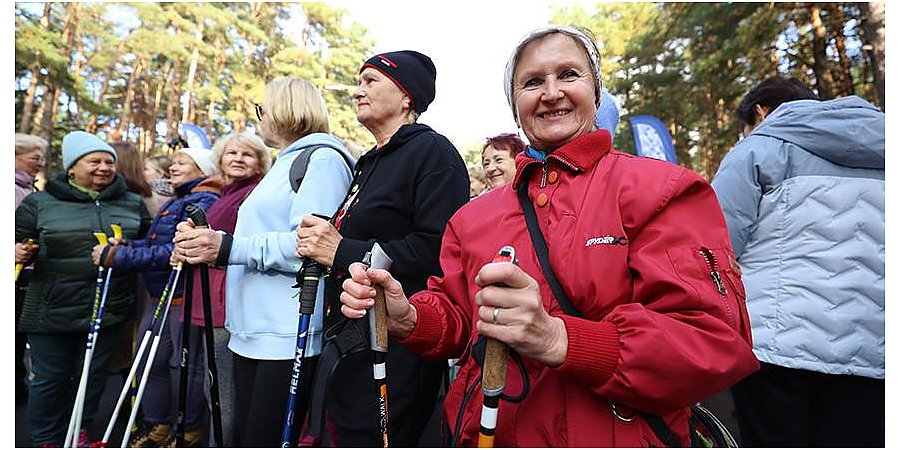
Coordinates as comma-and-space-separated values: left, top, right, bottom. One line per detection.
225, 133, 351, 360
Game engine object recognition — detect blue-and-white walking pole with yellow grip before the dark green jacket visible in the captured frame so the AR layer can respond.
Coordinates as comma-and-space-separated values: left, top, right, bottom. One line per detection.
63, 229, 121, 447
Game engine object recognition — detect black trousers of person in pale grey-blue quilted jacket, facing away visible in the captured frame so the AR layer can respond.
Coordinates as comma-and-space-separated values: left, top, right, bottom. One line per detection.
732, 363, 885, 447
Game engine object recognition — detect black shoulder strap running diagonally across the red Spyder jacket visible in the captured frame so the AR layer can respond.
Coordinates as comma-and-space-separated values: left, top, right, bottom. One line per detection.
518, 175, 681, 447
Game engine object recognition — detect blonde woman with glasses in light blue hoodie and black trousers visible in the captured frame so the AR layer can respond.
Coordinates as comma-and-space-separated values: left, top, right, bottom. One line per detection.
175, 78, 351, 447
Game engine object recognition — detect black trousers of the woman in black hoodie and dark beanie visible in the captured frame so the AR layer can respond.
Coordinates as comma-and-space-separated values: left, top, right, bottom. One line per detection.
326, 340, 447, 447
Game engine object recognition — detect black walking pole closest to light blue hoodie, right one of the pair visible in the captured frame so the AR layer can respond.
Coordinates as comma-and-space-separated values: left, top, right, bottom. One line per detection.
185, 204, 225, 447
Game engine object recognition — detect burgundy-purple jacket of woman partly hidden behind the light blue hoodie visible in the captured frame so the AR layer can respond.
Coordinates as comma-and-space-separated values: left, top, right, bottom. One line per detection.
187, 177, 261, 328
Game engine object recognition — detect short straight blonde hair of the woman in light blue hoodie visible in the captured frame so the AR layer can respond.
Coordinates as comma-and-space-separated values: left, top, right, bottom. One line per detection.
263, 78, 329, 139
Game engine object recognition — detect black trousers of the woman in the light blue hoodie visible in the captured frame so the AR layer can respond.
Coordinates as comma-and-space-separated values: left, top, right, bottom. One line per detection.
232, 353, 317, 448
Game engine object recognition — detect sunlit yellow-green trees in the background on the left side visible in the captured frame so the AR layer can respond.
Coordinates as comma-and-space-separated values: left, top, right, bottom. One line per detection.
15, 2, 373, 152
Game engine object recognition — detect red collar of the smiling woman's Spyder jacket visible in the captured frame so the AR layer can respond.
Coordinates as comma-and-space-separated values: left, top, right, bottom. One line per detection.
513, 130, 612, 188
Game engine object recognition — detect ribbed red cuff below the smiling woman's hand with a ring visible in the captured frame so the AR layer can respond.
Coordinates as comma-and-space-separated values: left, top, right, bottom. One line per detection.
554, 315, 619, 387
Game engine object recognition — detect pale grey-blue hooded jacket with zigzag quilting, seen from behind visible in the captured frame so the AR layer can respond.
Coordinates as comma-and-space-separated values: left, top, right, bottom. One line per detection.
712, 96, 885, 379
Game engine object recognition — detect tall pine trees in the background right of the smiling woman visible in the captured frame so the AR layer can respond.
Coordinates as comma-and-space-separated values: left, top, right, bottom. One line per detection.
552, 3, 875, 178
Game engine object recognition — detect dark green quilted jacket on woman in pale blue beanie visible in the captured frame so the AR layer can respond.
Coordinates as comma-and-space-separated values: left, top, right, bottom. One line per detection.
16, 174, 150, 333
